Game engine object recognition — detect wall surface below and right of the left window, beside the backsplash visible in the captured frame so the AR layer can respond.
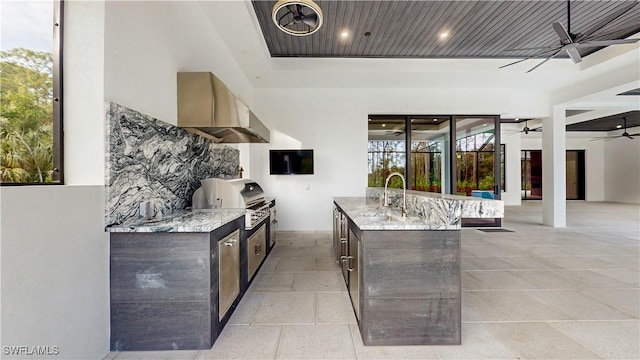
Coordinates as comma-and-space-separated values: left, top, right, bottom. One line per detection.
0, 1, 109, 359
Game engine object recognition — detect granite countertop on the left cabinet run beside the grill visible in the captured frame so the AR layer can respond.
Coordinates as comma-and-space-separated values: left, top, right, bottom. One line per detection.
105, 209, 245, 232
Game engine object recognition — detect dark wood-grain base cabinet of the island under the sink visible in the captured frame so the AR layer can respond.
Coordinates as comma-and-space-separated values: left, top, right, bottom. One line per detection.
334, 204, 462, 346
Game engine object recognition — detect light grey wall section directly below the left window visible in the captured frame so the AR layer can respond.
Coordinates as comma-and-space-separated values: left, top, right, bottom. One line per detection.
1, 186, 109, 359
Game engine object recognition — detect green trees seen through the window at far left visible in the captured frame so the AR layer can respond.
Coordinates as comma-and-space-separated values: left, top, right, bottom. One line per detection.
0, 48, 53, 183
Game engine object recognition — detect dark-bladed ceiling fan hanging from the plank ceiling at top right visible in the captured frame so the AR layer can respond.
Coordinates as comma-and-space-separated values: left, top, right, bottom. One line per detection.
500, 0, 640, 73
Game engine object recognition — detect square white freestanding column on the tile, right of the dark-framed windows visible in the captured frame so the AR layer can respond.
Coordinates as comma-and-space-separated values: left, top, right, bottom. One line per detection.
542, 105, 567, 227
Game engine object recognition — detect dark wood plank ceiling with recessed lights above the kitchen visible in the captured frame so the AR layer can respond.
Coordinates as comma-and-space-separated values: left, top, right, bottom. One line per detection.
252, 0, 640, 58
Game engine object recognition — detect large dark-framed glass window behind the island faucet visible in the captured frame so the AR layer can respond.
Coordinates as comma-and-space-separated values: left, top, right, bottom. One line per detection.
368, 115, 505, 198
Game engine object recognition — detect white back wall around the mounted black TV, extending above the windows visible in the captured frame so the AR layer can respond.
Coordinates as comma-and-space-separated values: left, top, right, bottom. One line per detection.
251, 88, 549, 230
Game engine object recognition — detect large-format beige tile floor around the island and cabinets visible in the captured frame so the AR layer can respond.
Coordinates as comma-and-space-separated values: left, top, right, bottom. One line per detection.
106, 201, 640, 360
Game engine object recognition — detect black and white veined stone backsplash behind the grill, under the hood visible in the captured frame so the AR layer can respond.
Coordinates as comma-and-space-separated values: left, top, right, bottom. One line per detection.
105, 102, 240, 226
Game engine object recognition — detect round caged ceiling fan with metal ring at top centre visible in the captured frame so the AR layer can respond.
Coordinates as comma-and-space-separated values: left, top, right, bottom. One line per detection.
271, 0, 323, 36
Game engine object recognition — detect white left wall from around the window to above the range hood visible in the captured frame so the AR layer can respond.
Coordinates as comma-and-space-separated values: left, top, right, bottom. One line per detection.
0, 0, 253, 359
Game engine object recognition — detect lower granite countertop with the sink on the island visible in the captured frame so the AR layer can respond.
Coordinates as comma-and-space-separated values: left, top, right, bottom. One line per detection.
333, 197, 460, 230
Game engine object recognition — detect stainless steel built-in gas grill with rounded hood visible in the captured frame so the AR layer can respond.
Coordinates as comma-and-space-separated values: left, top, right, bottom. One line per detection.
193, 178, 269, 230
